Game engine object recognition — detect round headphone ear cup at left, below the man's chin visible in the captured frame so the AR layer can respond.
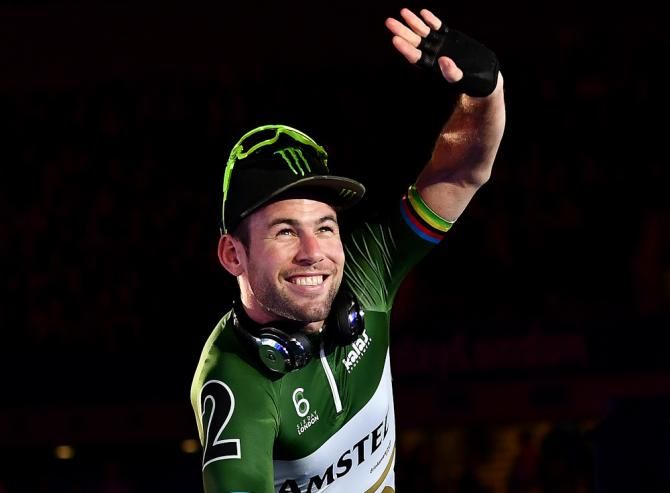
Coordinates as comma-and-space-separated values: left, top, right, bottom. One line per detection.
257, 327, 312, 373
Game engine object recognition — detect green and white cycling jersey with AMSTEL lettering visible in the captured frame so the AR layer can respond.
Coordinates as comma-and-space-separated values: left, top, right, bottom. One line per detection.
191, 192, 452, 493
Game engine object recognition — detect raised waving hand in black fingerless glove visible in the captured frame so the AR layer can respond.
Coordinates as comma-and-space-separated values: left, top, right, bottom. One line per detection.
385, 8, 499, 97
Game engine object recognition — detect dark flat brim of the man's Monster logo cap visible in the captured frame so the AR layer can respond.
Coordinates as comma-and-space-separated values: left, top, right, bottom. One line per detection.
240, 175, 365, 219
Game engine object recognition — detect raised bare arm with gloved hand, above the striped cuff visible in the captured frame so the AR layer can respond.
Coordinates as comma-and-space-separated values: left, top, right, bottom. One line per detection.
386, 9, 505, 221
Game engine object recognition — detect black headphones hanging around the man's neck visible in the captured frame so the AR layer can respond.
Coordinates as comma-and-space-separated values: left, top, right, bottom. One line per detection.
232, 289, 365, 373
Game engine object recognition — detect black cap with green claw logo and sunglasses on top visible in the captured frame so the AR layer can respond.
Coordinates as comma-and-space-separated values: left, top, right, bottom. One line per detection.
221, 125, 365, 233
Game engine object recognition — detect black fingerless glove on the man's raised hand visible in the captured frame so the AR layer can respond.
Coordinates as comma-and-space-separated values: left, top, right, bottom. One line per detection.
417, 26, 499, 97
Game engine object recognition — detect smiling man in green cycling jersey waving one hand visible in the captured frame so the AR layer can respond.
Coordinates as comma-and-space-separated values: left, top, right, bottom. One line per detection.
191, 5, 505, 493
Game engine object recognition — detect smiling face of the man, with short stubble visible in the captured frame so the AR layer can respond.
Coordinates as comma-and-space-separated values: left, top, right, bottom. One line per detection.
239, 199, 344, 331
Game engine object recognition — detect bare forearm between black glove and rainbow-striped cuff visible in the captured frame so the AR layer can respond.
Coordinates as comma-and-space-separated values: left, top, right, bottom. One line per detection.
416, 70, 505, 221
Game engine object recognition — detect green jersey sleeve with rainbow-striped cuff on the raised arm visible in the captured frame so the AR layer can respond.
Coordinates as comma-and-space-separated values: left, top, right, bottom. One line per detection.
345, 186, 451, 312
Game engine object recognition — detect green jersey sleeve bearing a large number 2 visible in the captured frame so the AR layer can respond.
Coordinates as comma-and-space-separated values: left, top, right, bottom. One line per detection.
191, 318, 279, 493
